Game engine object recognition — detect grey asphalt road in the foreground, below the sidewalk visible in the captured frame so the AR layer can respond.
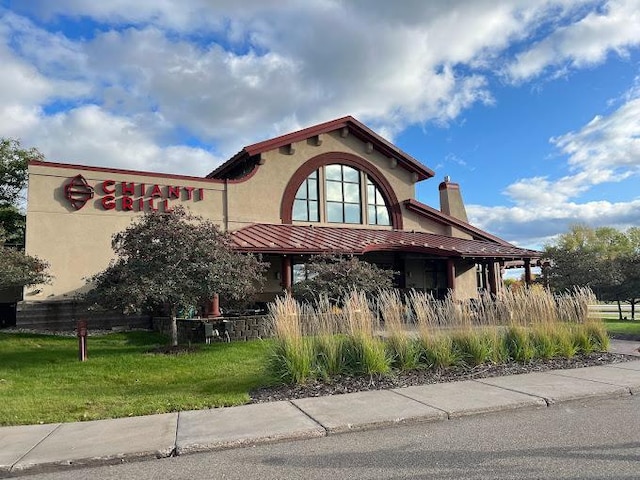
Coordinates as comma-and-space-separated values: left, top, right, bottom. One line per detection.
20, 396, 640, 480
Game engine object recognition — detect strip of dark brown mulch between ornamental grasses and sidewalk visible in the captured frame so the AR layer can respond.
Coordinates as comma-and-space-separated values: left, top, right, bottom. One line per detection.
249, 352, 638, 403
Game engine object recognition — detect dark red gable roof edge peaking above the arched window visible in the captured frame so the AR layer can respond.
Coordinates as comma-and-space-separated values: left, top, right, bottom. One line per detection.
207, 116, 435, 181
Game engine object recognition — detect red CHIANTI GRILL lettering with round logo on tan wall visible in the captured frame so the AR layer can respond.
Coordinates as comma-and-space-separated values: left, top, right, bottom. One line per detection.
64, 175, 204, 212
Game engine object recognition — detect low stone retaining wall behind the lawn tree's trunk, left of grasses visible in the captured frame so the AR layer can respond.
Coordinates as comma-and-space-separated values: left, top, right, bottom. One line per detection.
152, 315, 273, 344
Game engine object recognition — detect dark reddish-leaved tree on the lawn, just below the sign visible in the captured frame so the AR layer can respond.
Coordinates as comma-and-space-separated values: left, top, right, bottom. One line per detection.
86, 207, 267, 346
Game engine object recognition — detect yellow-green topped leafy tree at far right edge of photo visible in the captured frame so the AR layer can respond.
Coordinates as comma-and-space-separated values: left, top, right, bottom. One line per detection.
544, 225, 640, 318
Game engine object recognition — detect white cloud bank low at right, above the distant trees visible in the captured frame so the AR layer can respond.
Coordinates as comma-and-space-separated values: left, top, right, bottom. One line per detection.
467, 83, 640, 248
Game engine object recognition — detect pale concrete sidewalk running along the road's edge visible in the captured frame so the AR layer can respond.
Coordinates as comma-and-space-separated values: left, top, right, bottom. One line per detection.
0, 352, 640, 477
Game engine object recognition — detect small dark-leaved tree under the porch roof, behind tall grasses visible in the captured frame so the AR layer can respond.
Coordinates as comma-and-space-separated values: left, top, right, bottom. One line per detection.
294, 255, 396, 303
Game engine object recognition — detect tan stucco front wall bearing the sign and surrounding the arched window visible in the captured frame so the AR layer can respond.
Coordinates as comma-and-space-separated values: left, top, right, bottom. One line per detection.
25, 131, 476, 300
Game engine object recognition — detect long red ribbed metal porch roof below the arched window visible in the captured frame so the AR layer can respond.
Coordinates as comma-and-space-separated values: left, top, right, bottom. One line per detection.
232, 224, 541, 259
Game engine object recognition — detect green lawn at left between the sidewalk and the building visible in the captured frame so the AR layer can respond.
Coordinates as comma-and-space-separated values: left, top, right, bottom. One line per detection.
0, 332, 271, 425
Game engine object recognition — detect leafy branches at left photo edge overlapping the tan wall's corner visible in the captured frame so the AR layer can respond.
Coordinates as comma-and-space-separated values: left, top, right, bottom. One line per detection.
0, 227, 51, 289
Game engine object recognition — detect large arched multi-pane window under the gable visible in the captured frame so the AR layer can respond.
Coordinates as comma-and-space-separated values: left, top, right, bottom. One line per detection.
292, 163, 391, 226
